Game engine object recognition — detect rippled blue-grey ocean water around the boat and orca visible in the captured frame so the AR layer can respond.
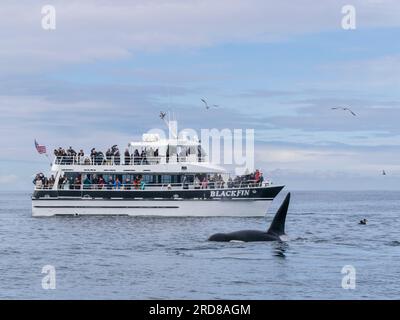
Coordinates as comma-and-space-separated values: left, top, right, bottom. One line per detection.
0, 191, 400, 299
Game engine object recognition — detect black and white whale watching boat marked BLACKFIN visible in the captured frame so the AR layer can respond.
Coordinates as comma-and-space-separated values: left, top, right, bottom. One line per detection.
32, 121, 284, 216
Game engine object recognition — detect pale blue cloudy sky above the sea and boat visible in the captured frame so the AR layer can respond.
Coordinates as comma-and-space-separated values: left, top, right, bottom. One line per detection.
0, 0, 400, 191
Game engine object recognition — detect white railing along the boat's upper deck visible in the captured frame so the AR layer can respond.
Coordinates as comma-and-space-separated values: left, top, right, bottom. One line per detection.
54, 155, 205, 166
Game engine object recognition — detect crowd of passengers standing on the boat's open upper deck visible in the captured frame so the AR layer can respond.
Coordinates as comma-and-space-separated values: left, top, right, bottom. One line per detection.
54, 145, 166, 165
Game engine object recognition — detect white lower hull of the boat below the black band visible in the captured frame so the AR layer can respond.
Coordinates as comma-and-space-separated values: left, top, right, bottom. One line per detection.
32, 199, 272, 217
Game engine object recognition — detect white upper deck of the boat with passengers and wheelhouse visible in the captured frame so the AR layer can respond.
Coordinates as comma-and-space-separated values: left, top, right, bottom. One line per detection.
52, 134, 225, 173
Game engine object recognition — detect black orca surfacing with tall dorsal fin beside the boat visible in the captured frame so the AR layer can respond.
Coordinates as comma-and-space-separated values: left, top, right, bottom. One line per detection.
208, 193, 290, 242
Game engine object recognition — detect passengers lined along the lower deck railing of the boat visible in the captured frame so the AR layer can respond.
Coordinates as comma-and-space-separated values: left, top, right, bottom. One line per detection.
33, 169, 264, 190
